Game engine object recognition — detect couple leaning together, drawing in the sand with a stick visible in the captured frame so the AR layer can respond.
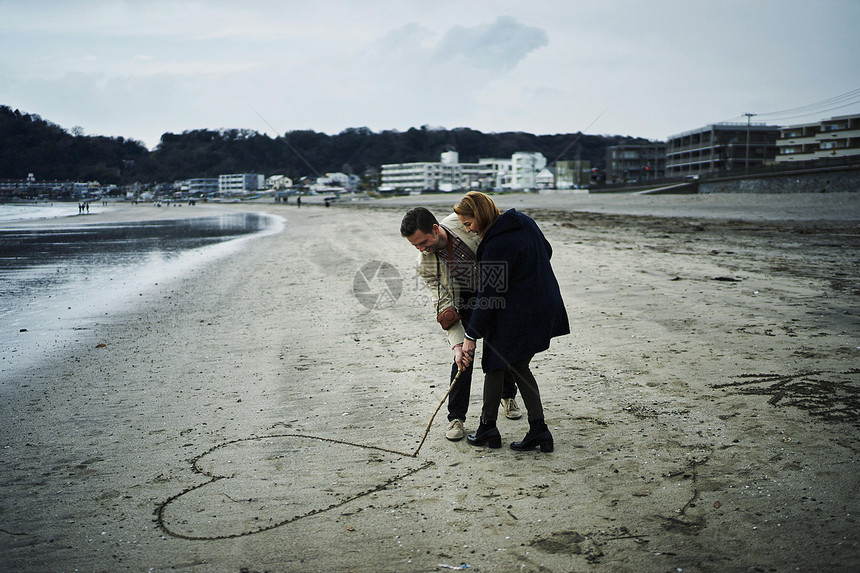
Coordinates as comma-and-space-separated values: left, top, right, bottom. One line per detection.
400, 191, 570, 452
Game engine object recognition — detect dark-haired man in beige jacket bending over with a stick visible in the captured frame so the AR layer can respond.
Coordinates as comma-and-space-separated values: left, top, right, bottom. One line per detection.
400, 207, 522, 441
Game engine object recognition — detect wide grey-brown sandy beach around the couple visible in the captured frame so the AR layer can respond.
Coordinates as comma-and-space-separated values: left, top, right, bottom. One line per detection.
0, 193, 860, 573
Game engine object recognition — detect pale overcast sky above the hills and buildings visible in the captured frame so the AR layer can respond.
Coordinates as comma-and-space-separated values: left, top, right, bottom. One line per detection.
0, 0, 860, 149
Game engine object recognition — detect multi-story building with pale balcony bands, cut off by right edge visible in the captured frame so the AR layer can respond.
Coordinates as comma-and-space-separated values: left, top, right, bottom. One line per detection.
776, 114, 860, 163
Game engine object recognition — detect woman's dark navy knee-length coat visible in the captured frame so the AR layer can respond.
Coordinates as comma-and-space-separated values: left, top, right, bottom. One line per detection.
466, 209, 570, 372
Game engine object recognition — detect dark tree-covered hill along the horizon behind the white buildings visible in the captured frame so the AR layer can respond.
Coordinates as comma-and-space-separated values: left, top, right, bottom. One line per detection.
0, 106, 645, 184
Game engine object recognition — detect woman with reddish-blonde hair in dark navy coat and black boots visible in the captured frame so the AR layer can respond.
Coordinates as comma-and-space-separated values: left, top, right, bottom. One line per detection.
454, 191, 570, 452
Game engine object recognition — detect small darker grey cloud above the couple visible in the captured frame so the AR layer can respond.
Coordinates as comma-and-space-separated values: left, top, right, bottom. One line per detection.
435, 16, 549, 71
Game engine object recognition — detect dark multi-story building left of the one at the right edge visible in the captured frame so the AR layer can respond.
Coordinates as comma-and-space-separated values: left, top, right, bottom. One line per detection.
666, 123, 779, 177
